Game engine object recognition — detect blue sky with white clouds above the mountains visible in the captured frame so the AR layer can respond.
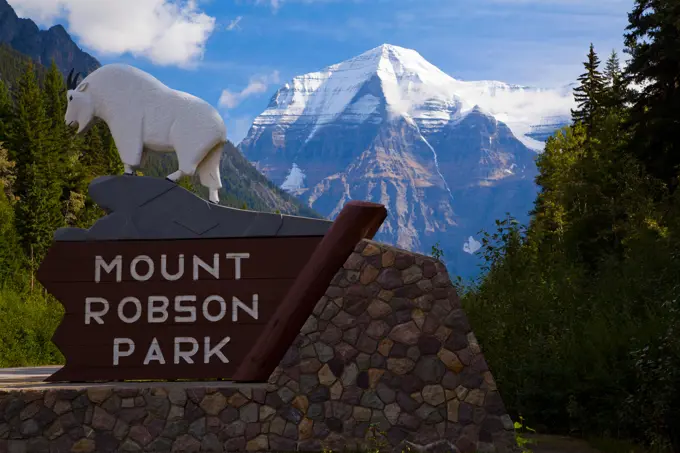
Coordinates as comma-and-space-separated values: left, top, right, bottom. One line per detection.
9, 0, 633, 142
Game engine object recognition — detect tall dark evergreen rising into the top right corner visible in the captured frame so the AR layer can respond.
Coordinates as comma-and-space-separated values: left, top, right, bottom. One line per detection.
625, 0, 680, 191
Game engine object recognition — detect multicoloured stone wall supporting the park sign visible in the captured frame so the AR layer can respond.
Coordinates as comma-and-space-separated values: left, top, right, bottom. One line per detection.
0, 241, 516, 453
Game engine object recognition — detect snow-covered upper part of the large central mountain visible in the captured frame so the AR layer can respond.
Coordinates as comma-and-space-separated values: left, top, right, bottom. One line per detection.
254, 43, 573, 151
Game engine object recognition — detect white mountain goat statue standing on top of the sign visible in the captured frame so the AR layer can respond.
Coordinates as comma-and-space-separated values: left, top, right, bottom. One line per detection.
65, 64, 227, 203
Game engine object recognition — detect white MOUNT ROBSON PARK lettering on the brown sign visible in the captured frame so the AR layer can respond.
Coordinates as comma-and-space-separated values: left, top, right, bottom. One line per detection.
90, 253, 259, 366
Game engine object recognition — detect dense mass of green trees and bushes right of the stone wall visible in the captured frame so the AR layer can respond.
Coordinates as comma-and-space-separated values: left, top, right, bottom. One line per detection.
463, 4, 680, 453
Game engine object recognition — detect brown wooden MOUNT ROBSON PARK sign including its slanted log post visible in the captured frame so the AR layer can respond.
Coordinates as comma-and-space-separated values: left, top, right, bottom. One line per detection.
38, 202, 386, 382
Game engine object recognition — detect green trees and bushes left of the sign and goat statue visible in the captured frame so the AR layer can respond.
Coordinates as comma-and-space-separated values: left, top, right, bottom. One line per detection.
0, 53, 117, 366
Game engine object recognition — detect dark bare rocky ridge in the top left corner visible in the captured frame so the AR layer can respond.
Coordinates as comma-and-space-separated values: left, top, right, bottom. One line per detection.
0, 0, 101, 74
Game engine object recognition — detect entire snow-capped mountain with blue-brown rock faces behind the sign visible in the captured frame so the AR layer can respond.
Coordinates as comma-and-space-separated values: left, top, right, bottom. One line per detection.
240, 44, 573, 276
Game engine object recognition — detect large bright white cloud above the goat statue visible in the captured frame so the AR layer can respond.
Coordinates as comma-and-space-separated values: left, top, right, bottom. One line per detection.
11, 0, 215, 66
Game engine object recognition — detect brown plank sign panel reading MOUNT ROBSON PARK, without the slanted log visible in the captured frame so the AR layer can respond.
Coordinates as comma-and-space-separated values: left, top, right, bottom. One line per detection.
41, 237, 320, 380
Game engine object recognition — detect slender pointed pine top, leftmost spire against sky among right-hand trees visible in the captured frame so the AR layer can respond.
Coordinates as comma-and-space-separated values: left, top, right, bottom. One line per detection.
571, 44, 604, 136
